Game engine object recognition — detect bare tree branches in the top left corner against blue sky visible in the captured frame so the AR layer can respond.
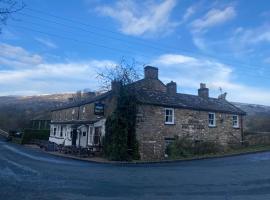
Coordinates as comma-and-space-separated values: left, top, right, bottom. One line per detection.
0, 0, 25, 33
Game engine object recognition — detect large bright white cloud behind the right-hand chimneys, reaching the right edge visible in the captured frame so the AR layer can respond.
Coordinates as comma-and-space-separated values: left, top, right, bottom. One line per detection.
152, 54, 270, 105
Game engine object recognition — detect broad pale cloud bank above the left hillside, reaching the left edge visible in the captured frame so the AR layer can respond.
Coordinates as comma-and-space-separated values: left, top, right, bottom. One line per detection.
0, 44, 115, 95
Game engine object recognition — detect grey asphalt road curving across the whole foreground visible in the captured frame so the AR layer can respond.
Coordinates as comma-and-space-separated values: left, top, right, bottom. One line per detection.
0, 137, 270, 200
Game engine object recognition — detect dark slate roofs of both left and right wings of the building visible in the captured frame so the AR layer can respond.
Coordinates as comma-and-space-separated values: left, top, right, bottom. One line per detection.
52, 80, 246, 115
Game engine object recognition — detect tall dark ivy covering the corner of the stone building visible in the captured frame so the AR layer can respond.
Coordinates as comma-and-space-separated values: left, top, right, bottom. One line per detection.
104, 85, 139, 161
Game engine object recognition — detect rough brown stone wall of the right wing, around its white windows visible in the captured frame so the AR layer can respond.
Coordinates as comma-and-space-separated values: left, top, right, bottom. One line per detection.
136, 105, 244, 160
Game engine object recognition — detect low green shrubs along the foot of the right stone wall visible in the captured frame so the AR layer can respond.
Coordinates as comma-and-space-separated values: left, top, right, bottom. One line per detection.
167, 137, 222, 159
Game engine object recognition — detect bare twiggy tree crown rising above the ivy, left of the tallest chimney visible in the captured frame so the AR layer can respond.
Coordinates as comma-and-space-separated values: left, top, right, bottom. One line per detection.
97, 58, 141, 91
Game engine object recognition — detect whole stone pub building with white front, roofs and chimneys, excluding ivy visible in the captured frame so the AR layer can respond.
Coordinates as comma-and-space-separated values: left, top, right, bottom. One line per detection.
50, 66, 245, 160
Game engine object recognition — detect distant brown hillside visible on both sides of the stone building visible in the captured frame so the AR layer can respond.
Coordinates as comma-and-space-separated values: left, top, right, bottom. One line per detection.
0, 93, 270, 132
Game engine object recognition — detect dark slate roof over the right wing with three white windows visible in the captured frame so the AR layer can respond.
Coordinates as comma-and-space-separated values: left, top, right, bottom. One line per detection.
136, 90, 246, 115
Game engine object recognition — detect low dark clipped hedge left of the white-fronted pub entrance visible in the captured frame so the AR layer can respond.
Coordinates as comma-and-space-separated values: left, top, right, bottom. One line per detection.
22, 129, 50, 144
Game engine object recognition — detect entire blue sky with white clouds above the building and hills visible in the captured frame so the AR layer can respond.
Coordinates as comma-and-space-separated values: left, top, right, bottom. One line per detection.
0, 0, 270, 105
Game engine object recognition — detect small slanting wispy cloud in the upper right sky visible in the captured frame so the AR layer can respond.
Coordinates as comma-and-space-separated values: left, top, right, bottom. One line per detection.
191, 6, 236, 32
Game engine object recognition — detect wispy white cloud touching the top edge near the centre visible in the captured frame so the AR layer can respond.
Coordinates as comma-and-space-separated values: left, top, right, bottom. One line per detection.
96, 0, 177, 36
